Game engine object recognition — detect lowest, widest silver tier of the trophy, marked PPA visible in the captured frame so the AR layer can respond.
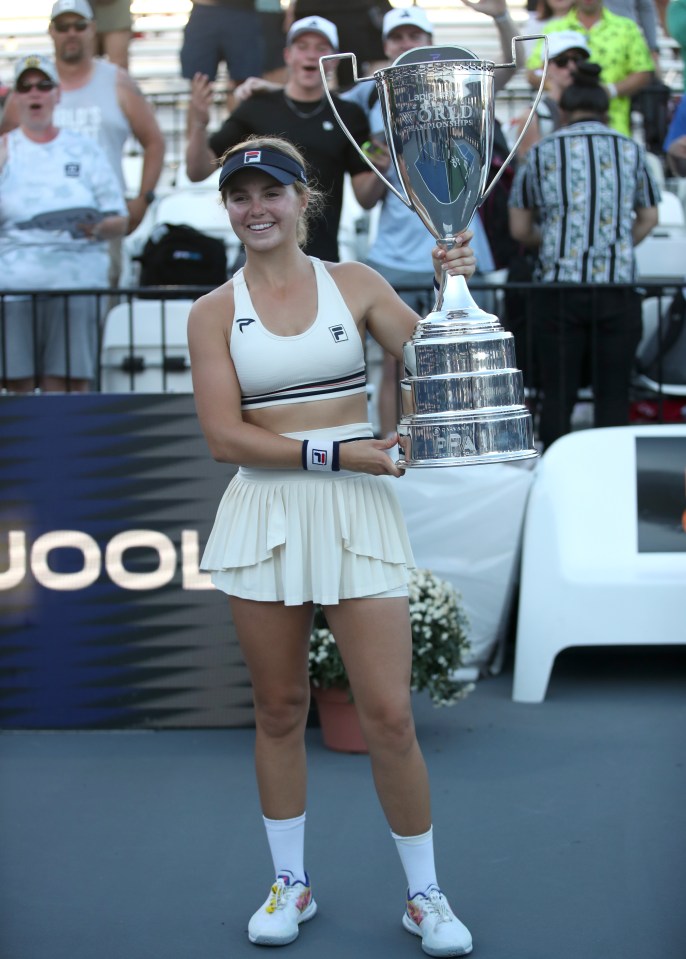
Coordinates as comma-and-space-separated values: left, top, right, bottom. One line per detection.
397, 407, 538, 469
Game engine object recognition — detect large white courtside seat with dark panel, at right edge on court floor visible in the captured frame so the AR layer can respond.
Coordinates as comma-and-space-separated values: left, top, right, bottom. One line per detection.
512, 425, 686, 703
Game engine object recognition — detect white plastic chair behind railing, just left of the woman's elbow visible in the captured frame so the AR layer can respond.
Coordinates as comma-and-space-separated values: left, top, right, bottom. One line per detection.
100, 300, 193, 393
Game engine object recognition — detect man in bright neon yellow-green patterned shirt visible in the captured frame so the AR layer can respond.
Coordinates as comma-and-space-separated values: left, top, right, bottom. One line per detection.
526, 0, 655, 136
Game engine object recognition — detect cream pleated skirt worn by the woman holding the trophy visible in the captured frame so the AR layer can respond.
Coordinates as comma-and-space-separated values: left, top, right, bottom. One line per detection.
200, 423, 415, 606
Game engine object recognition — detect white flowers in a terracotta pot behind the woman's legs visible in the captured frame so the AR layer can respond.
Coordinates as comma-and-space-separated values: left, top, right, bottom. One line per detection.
310, 569, 473, 752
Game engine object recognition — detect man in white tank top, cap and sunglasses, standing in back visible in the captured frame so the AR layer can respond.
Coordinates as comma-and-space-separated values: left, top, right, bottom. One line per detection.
0, 0, 164, 240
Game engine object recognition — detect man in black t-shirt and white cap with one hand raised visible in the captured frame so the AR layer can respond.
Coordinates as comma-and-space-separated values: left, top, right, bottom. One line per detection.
186, 17, 383, 261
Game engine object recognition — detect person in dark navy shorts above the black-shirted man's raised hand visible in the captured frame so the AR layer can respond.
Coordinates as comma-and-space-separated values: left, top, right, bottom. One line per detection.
181, 0, 263, 109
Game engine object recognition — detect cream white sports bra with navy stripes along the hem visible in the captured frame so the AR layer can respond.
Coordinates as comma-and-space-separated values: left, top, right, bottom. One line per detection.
230, 257, 367, 410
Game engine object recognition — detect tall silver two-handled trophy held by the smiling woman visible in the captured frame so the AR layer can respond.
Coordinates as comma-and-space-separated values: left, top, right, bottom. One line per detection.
320, 37, 548, 467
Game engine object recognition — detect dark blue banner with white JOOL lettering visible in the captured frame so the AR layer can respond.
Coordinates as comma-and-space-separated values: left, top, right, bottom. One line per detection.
0, 394, 253, 729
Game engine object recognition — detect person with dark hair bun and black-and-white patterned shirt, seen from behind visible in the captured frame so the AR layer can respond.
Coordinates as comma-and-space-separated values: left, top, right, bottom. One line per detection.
510, 63, 660, 446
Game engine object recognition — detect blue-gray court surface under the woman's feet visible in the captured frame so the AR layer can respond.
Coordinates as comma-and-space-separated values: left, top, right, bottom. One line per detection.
0, 648, 686, 959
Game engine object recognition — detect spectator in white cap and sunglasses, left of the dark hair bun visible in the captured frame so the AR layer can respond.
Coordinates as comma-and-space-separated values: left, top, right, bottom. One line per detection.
516, 30, 591, 157
